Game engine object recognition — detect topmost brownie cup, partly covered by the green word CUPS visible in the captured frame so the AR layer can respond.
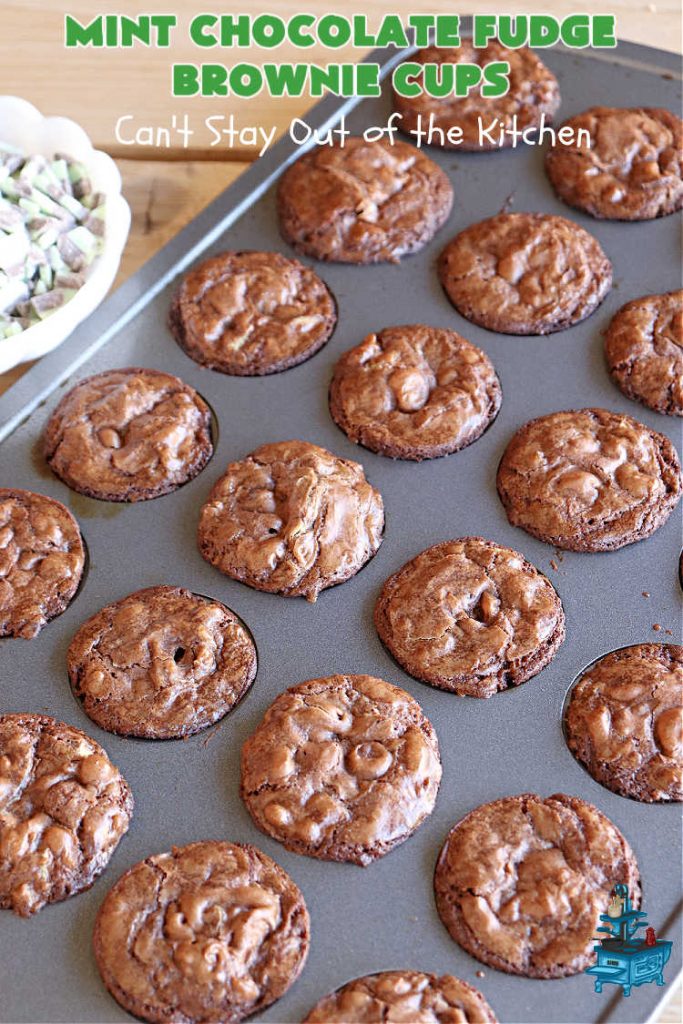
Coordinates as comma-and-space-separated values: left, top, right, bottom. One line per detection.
393, 39, 560, 151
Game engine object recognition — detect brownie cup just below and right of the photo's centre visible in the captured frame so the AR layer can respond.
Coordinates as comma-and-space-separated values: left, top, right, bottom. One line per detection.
375, 537, 564, 697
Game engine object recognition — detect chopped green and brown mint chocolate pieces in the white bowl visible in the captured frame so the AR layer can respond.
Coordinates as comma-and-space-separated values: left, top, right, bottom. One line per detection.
0, 148, 106, 341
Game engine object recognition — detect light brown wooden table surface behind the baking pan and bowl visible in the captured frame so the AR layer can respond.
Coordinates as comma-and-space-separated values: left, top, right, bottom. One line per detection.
0, 0, 683, 1024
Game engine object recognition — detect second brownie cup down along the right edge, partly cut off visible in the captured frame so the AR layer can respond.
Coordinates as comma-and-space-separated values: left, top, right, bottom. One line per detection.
605, 291, 683, 416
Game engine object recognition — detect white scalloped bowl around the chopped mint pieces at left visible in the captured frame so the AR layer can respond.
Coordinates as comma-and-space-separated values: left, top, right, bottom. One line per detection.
0, 96, 130, 373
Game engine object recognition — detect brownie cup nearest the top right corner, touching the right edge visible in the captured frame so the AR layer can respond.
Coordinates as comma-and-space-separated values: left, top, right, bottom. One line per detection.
546, 106, 683, 220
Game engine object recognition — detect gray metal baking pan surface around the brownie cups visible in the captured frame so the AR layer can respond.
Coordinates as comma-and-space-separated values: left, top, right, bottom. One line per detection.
0, 32, 682, 1022
